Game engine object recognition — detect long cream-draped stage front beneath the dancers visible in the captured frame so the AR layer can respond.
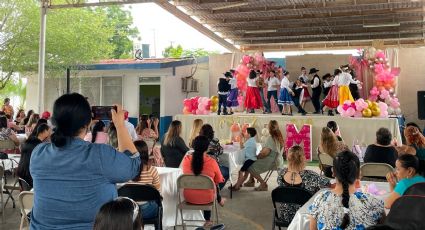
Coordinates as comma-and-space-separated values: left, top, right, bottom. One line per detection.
174, 113, 402, 159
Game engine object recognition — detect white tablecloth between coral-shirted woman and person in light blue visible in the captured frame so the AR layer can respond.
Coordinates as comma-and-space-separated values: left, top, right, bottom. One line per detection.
219, 143, 261, 182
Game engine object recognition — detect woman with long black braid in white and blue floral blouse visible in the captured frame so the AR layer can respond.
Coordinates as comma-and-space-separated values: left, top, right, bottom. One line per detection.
308, 151, 385, 230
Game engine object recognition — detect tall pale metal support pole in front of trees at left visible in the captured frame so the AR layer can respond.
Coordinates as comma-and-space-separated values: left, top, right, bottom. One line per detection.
37, 0, 48, 113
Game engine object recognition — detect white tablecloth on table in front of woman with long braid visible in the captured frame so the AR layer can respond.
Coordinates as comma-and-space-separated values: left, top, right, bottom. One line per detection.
287, 181, 390, 230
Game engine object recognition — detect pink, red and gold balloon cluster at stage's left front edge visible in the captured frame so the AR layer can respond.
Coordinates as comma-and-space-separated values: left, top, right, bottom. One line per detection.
183, 96, 218, 115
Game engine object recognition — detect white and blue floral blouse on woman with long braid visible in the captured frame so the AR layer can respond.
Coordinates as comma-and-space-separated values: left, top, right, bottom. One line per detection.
309, 190, 384, 230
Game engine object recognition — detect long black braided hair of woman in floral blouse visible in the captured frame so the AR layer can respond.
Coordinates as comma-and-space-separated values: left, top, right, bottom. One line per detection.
333, 151, 360, 229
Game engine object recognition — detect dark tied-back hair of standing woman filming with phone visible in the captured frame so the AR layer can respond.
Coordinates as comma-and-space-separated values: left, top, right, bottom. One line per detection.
52, 93, 92, 147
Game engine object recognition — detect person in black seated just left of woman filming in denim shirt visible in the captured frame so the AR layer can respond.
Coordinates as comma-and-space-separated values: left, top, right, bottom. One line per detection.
17, 137, 41, 187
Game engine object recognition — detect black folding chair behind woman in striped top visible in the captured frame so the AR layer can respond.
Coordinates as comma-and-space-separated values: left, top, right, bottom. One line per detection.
118, 183, 163, 230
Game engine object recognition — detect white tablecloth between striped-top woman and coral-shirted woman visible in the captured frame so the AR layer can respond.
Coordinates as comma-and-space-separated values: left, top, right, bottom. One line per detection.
152, 167, 204, 229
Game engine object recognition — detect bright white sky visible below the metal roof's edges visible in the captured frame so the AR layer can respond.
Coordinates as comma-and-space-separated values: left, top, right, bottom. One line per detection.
127, 3, 357, 58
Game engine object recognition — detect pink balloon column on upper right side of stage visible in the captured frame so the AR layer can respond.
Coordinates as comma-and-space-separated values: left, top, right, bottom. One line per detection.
365, 47, 400, 93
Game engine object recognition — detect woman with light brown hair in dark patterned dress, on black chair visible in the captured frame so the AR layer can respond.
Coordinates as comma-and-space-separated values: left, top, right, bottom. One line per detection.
277, 146, 330, 223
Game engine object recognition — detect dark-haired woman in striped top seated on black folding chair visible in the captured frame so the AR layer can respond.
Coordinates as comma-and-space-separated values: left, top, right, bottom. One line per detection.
133, 140, 161, 219
